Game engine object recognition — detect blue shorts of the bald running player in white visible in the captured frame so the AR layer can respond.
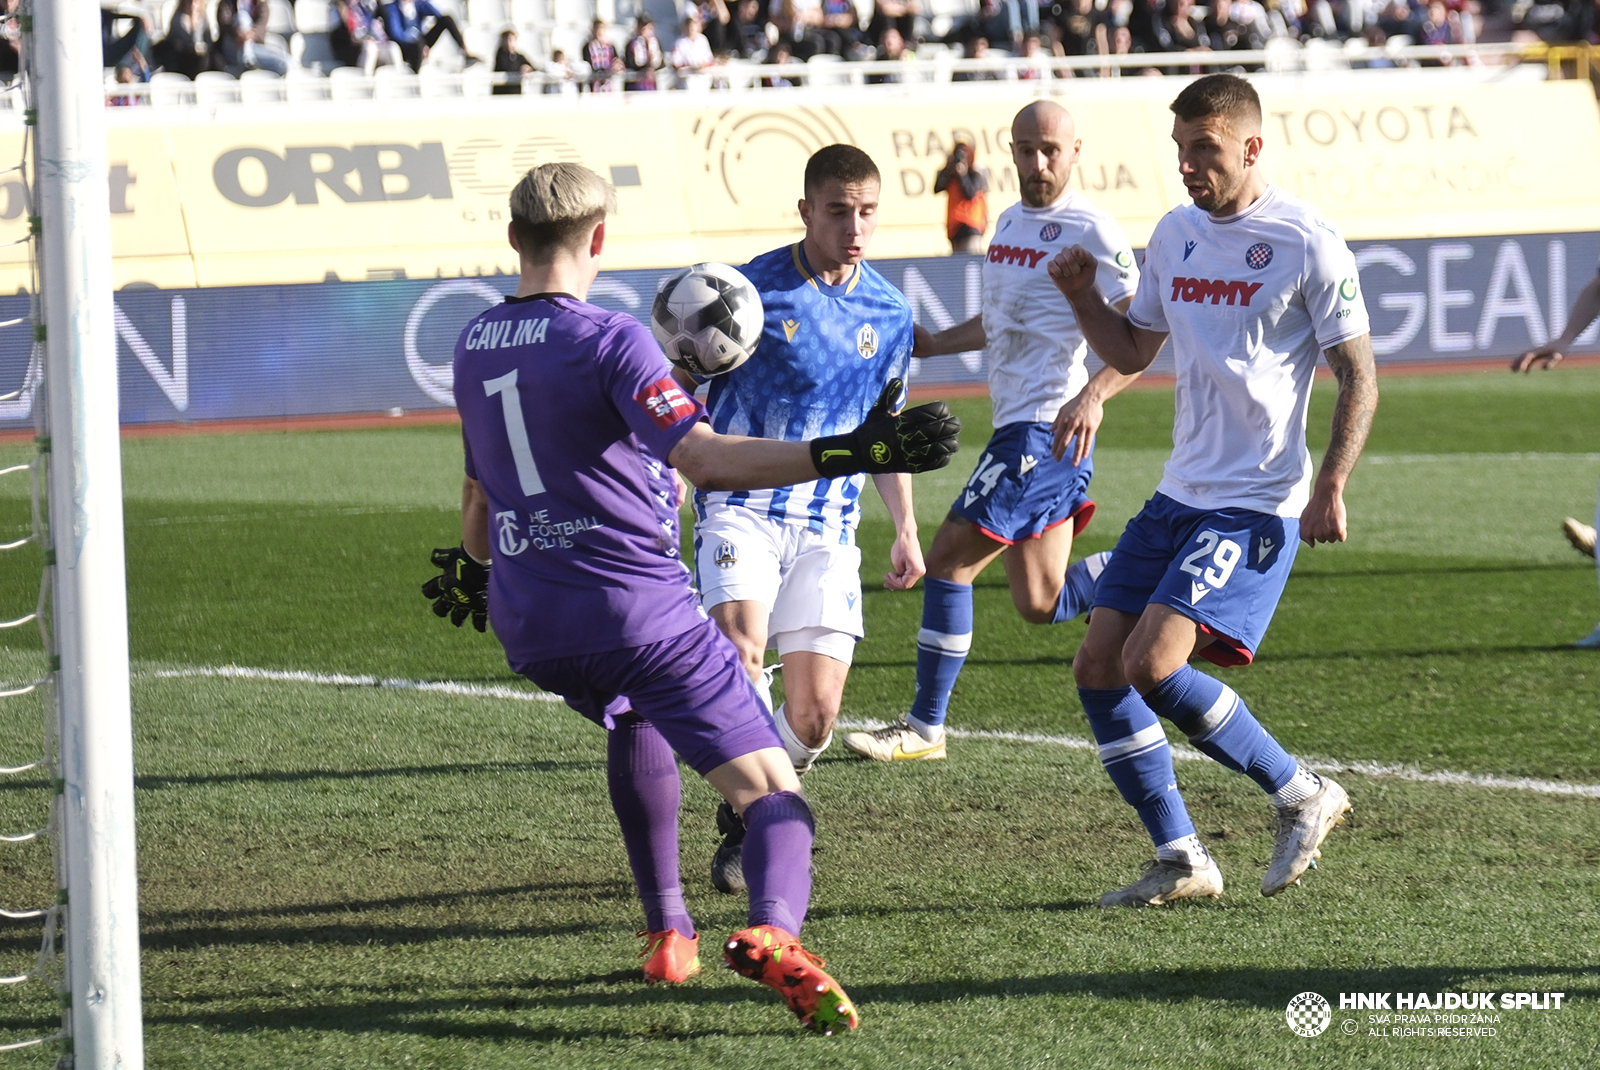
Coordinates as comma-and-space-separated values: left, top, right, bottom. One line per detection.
950, 424, 1094, 545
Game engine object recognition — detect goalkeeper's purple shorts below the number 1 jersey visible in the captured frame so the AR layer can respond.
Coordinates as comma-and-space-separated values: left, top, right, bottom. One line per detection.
512, 621, 784, 776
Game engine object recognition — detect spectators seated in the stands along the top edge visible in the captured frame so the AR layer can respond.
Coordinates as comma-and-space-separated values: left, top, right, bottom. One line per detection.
9, 0, 1600, 101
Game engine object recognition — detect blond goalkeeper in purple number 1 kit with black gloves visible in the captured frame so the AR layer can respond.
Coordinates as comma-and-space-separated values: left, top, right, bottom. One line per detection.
422, 163, 960, 1032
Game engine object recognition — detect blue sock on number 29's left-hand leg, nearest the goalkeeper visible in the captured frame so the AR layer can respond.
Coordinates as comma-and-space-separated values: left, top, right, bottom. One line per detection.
1078, 688, 1195, 846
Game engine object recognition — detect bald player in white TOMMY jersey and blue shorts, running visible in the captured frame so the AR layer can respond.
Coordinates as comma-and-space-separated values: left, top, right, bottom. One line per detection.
845, 101, 1139, 761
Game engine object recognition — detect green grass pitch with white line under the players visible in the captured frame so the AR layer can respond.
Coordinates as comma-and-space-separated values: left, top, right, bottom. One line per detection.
0, 368, 1600, 1070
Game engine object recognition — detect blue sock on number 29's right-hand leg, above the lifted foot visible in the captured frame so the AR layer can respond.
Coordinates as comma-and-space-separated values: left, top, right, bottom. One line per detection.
1144, 665, 1299, 793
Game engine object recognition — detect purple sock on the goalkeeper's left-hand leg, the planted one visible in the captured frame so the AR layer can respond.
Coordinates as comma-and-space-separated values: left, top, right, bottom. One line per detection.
605, 713, 694, 936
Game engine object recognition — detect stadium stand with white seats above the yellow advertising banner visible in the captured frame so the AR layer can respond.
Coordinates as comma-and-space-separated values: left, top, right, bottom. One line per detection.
81, 0, 1600, 107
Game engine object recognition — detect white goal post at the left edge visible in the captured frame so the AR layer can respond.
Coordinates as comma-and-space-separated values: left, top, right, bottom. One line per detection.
22, 0, 144, 1070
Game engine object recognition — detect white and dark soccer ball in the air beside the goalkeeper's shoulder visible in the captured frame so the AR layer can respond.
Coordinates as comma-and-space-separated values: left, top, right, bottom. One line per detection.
650, 264, 763, 376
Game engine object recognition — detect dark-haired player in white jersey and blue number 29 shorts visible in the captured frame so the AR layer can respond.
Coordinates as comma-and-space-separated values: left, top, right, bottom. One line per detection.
1050, 75, 1378, 907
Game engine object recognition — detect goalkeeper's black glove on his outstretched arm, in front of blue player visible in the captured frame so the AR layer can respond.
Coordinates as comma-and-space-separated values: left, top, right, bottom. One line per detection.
811, 379, 962, 478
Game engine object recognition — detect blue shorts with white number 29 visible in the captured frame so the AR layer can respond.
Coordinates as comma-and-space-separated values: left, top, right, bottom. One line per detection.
1094, 494, 1299, 665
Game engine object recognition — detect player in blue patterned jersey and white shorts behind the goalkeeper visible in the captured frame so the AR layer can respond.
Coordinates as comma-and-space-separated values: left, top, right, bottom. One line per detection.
675, 146, 923, 892
